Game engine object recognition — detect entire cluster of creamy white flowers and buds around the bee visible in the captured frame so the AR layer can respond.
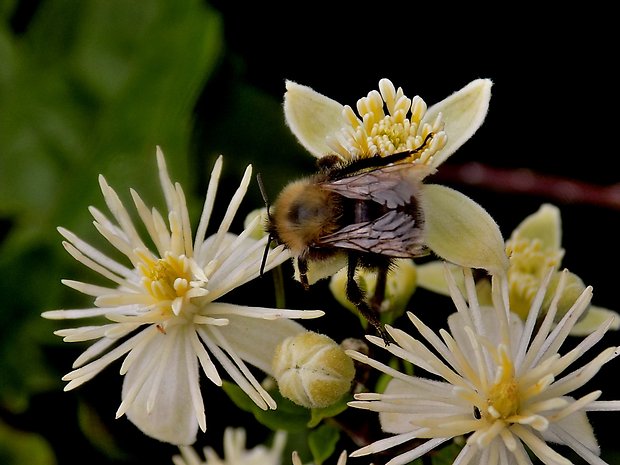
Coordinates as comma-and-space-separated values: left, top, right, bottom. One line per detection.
43, 79, 620, 465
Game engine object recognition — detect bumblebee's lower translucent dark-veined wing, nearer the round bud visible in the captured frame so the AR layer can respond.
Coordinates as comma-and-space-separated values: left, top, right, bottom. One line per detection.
320, 210, 427, 258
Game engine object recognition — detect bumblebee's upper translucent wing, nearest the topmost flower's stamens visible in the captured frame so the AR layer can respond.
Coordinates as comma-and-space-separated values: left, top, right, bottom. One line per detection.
321, 163, 432, 208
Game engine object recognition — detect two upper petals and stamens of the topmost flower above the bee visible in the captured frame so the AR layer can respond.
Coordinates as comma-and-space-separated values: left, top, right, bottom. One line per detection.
284, 79, 492, 168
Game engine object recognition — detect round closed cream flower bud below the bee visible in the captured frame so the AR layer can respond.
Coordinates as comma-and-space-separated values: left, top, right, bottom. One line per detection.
273, 331, 355, 408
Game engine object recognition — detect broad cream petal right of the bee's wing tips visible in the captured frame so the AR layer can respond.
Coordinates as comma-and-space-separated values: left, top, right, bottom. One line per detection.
421, 184, 508, 275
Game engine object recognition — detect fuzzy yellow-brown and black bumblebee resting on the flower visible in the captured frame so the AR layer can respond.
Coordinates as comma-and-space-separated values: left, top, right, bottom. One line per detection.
261, 134, 432, 343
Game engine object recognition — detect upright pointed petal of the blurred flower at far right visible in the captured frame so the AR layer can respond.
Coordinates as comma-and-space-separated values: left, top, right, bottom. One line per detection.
512, 203, 562, 251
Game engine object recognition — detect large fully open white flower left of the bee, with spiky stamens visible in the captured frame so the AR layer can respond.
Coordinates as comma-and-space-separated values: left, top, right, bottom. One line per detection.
43, 148, 323, 444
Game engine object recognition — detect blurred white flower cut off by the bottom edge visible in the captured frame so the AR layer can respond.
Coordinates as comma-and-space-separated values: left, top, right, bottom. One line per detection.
172, 427, 286, 465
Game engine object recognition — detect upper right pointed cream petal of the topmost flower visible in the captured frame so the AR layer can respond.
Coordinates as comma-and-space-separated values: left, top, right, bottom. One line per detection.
423, 79, 493, 168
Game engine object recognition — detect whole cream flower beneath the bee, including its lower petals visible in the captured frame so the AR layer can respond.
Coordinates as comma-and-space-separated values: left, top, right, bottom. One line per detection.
284, 79, 508, 283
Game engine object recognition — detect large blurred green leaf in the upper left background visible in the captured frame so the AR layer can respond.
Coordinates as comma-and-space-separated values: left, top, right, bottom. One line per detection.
0, 0, 222, 239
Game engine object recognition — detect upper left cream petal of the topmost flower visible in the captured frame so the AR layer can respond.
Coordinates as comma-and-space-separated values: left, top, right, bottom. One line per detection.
284, 81, 344, 158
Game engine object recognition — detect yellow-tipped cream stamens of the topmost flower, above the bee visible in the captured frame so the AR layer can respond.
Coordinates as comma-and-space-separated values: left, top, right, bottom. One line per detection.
328, 79, 447, 164
